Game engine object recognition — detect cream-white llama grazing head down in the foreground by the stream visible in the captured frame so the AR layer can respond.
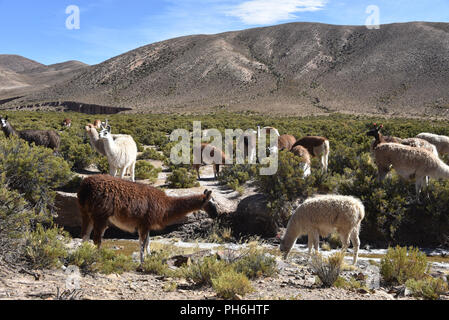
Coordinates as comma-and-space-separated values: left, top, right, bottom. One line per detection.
280, 195, 365, 265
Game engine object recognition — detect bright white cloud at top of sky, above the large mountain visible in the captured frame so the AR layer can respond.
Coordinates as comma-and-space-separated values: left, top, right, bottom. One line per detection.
226, 0, 327, 25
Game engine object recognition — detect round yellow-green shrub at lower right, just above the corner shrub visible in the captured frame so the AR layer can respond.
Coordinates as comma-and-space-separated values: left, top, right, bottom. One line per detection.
380, 246, 428, 284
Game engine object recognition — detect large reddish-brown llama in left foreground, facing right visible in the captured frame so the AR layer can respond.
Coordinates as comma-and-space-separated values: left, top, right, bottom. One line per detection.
78, 175, 218, 263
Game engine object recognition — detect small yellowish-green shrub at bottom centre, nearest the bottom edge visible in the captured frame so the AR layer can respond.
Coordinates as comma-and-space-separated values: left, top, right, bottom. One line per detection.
212, 269, 254, 300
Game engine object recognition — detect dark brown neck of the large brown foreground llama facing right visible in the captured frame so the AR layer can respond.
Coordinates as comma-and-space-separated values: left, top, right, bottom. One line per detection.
164, 195, 204, 224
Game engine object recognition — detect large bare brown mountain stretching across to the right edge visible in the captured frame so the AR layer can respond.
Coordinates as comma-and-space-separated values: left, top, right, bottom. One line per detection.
0, 22, 449, 116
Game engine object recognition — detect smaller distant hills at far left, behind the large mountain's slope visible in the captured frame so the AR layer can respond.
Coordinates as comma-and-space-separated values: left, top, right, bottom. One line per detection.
0, 54, 87, 99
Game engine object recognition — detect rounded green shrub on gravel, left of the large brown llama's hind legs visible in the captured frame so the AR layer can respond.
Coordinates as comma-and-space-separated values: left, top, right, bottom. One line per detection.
25, 224, 69, 269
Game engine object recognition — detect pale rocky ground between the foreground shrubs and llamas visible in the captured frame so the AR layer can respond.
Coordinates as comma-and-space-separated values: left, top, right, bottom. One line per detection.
0, 161, 449, 300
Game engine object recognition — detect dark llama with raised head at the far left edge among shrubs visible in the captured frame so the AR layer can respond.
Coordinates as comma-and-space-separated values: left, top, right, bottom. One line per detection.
0, 116, 61, 153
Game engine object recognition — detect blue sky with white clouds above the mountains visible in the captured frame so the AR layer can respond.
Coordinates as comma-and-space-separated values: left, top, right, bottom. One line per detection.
0, 0, 449, 64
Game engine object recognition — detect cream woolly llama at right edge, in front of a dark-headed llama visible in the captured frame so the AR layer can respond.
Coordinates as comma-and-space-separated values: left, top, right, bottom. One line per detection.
373, 143, 449, 195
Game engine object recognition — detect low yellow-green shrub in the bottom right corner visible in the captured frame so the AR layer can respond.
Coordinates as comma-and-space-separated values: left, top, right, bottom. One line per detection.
405, 277, 449, 300
